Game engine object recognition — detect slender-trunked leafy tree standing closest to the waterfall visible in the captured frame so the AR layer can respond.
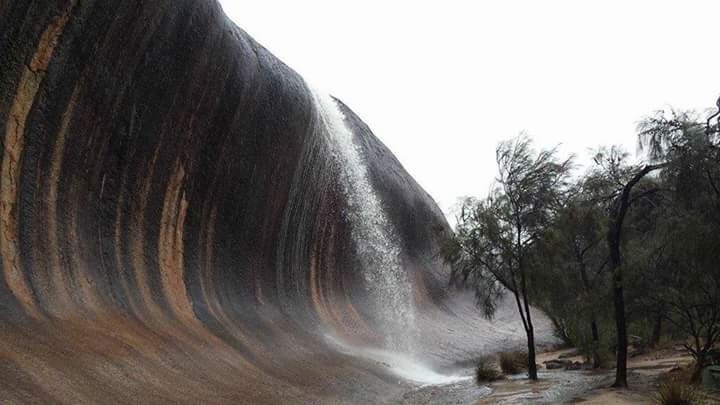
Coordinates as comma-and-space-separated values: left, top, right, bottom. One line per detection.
441, 135, 572, 380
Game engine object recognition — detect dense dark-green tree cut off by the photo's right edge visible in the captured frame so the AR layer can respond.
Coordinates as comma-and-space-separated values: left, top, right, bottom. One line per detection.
640, 100, 720, 381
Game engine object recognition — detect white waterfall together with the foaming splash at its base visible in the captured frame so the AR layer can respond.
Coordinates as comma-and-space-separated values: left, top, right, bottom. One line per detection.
313, 91, 471, 385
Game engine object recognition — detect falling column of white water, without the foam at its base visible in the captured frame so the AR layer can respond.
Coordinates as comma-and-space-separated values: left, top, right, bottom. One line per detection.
313, 91, 415, 352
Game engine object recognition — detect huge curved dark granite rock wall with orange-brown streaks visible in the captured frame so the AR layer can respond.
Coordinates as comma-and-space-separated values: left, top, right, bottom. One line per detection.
0, 0, 552, 403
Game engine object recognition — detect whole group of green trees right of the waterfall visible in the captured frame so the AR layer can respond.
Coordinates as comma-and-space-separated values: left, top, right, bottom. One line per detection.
439, 100, 720, 387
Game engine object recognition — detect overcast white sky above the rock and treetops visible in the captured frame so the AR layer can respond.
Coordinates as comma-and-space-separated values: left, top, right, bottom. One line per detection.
221, 0, 720, 218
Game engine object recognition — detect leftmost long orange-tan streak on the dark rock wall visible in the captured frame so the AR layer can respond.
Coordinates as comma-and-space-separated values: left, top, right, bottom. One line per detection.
0, 0, 75, 318
